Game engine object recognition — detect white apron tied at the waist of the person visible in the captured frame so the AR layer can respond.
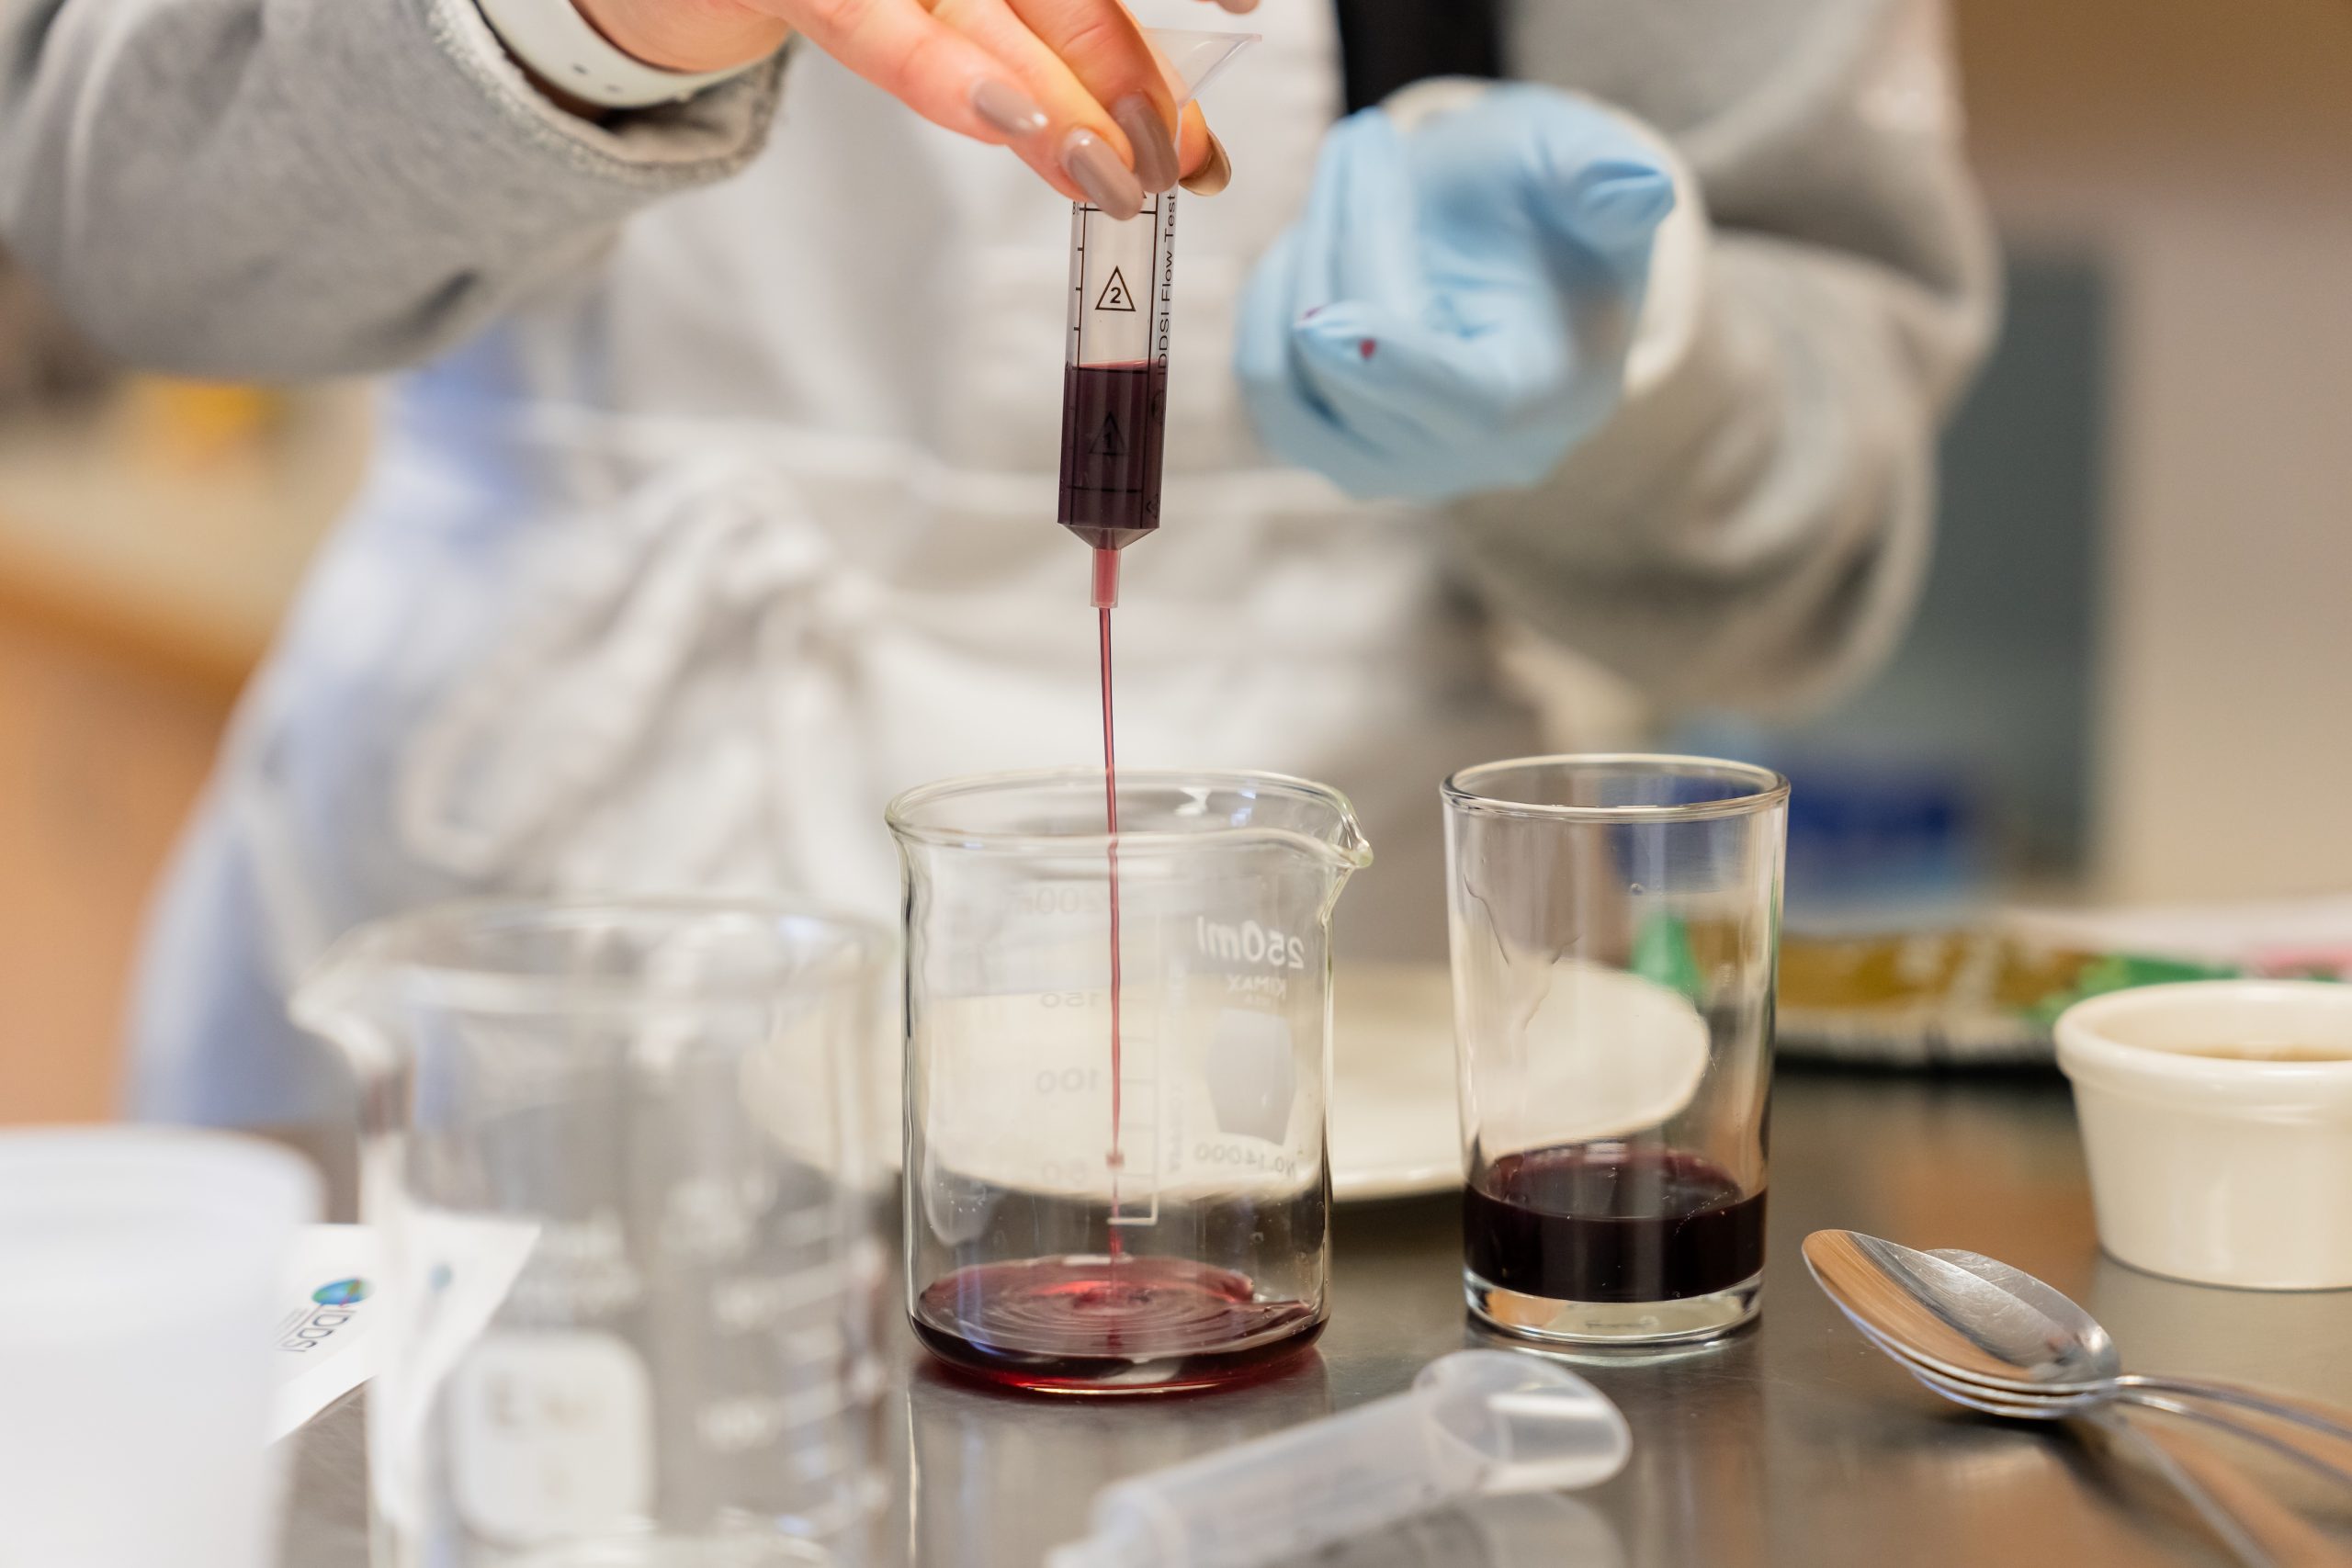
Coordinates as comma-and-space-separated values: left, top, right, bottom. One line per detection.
119, 0, 1994, 1123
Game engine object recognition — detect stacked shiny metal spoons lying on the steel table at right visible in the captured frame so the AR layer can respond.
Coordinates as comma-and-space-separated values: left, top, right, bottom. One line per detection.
1804, 1229, 2352, 1448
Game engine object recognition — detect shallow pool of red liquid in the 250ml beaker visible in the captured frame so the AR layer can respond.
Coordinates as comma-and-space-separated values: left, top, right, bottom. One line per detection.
915, 1258, 1322, 1394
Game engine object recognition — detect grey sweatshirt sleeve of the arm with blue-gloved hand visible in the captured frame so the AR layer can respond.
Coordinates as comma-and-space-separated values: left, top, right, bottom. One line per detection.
1456, 0, 1996, 707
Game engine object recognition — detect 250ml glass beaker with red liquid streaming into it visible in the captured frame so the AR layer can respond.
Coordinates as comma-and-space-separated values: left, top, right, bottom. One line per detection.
889, 769, 1371, 1394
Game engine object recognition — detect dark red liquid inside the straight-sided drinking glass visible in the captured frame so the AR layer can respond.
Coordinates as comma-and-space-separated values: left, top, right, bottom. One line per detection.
1463, 1143, 1764, 1303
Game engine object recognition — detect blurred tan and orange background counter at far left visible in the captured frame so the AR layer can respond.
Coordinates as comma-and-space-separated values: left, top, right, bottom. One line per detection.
0, 350, 367, 1123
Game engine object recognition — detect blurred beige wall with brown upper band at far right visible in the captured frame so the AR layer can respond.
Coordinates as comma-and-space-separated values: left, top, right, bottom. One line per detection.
1962, 0, 2352, 898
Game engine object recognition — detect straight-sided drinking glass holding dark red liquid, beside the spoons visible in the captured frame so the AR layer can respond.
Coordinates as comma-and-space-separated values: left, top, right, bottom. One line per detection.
1444, 757, 1788, 1345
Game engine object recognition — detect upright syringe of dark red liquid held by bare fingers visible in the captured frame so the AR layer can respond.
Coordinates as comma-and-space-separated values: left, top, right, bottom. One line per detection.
1061, 28, 1256, 609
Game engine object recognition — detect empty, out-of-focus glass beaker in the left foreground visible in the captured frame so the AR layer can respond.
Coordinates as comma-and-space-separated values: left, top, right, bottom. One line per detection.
294, 900, 889, 1568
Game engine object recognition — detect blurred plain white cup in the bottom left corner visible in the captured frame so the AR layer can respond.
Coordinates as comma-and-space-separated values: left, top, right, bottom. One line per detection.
0, 1128, 320, 1568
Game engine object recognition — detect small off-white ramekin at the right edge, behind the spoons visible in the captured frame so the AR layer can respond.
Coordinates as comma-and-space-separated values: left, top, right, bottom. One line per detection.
2058, 980, 2352, 1291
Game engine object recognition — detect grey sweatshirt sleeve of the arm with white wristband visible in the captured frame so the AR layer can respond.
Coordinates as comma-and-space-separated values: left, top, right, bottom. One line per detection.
0, 0, 778, 376
